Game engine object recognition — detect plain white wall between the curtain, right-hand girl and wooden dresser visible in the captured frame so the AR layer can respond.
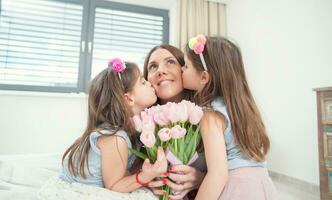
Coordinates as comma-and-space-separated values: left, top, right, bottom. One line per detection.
227, 0, 332, 184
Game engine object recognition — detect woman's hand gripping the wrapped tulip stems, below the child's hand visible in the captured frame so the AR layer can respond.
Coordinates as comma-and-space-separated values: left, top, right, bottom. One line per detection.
166, 165, 205, 200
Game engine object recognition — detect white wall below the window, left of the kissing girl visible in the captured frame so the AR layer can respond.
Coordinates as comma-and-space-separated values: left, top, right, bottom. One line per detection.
0, 91, 87, 155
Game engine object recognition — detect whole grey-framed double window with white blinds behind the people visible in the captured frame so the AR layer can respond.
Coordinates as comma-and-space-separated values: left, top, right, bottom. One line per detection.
0, 0, 169, 92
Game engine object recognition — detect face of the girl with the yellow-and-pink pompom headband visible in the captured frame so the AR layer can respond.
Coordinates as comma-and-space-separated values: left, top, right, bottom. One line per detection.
181, 54, 204, 91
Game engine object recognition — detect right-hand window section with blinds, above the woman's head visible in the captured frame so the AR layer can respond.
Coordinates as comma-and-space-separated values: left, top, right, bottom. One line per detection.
91, 3, 168, 77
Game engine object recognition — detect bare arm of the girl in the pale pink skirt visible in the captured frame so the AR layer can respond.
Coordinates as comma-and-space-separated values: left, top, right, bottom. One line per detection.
195, 112, 228, 200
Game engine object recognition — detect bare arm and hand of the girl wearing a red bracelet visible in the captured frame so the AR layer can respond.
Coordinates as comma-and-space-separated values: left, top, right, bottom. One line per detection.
97, 136, 167, 192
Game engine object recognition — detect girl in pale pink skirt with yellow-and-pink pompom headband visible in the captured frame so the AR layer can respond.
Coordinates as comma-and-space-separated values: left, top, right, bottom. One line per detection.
182, 35, 275, 200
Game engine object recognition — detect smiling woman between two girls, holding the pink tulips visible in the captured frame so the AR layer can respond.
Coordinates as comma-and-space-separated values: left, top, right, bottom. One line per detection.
143, 44, 206, 199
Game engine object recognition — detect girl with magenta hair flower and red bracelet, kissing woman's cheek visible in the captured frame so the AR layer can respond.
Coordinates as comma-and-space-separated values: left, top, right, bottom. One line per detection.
60, 58, 167, 192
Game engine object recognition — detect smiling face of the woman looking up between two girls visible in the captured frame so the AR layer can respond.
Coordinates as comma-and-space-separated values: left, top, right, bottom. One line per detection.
147, 48, 183, 103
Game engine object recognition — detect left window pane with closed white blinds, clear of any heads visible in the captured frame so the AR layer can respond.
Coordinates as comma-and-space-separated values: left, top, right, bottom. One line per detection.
0, 0, 83, 91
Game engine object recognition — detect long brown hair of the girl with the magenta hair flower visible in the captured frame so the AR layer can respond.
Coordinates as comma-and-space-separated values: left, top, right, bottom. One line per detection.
62, 62, 140, 178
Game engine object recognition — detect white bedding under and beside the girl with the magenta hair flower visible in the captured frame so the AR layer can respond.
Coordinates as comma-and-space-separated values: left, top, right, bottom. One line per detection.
0, 154, 158, 200
